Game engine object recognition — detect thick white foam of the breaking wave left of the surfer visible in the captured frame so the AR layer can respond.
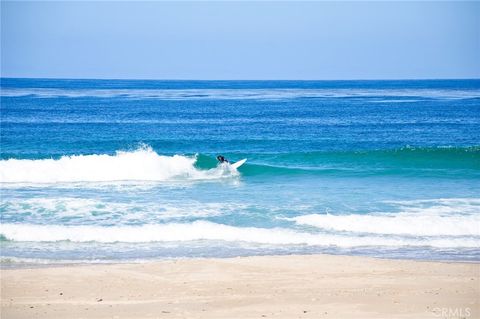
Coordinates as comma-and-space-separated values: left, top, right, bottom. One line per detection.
0, 147, 234, 184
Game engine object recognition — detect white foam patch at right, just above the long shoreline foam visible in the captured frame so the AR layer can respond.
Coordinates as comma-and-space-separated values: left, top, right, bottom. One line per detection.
289, 198, 480, 237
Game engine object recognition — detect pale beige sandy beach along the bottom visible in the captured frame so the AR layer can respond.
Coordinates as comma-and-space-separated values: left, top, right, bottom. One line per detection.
1, 255, 480, 319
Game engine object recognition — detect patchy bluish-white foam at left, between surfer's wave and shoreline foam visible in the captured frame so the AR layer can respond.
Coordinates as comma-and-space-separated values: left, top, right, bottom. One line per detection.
0, 197, 237, 225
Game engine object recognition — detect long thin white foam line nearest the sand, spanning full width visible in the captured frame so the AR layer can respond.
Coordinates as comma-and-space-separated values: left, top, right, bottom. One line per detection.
0, 221, 479, 247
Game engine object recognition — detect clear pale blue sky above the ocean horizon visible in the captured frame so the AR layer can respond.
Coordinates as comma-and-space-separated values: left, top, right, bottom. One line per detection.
1, 0, 480, 80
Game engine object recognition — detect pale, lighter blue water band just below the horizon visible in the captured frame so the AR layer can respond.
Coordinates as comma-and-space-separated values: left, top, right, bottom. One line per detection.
0, 88, 480, 102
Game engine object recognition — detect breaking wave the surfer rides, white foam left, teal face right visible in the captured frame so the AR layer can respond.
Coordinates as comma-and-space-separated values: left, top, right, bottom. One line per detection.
0, 146, 480, 184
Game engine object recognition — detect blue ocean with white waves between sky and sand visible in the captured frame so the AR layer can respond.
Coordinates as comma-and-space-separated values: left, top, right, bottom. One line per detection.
0, 78, 480, 267
